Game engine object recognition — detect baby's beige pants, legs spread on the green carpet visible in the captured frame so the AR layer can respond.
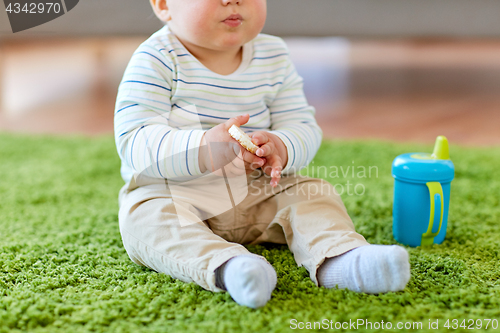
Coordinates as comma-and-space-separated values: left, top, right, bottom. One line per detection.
119, 169, 368, 292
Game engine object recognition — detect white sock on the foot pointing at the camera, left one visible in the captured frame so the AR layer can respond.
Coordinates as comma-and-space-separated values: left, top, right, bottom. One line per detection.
215, 254, 277, 309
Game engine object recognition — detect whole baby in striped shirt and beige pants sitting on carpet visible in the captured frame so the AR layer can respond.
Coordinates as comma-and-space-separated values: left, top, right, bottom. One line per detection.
114, 0, 410, 308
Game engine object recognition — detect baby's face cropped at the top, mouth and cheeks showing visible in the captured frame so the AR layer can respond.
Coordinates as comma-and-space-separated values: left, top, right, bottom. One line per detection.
166, 0, 267, 51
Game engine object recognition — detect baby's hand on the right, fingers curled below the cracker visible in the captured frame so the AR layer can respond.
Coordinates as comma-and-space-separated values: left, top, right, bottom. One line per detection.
251, 131, 288, 187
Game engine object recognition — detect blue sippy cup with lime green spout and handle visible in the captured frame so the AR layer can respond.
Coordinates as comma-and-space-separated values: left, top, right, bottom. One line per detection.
392, 136, 455, 247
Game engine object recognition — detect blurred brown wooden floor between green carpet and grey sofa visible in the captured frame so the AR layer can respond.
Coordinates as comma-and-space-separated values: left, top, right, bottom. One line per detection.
0, 38, 500, 146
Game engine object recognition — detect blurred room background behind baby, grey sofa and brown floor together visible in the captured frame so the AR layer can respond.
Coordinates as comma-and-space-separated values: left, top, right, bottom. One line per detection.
0, 0, 500, 146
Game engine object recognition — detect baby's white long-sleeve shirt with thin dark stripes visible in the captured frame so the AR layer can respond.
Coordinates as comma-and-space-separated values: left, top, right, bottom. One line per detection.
114, 25, 322, 183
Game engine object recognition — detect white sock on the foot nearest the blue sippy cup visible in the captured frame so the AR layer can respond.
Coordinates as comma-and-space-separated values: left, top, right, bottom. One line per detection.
317, 244, 410, 294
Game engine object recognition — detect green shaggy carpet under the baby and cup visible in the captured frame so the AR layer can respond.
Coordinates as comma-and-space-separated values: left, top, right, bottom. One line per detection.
0, 133, 500, 333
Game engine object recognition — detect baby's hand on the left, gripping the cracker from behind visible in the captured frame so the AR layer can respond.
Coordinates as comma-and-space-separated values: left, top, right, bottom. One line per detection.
199, 114, 266, 177
